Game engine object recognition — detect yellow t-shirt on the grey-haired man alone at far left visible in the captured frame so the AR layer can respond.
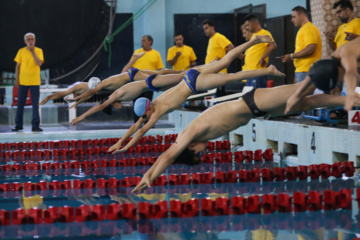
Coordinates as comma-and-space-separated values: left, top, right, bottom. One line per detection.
14, 47, 44, 86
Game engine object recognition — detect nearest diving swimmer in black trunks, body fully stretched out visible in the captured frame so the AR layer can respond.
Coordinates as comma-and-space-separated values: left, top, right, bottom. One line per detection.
133, 83, 360, 192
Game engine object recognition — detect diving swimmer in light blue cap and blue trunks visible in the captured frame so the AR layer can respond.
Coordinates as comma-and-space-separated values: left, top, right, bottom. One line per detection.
109, 35, 285, 152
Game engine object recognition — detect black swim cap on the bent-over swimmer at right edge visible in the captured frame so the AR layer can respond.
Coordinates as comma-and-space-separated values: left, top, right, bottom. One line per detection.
309, 59, 339, 91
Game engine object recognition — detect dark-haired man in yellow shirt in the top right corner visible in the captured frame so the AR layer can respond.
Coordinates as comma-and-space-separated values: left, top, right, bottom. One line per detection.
324, 0, 360, 50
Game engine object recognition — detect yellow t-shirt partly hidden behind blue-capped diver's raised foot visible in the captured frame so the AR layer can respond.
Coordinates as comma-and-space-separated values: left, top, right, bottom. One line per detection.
243, 29, 274, 70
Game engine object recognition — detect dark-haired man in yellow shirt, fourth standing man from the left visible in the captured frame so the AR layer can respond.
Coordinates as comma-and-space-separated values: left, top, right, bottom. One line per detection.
203, 20, 234, 73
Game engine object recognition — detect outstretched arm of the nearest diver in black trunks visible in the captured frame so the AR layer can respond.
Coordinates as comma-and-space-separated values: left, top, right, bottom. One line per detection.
132, 126, 201, 193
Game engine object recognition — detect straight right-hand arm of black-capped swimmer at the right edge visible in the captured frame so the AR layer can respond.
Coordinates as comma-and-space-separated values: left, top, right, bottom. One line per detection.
341, 53, 358, 111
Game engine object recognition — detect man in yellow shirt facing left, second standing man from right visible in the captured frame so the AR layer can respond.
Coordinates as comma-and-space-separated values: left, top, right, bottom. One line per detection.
281, 6, 322, 83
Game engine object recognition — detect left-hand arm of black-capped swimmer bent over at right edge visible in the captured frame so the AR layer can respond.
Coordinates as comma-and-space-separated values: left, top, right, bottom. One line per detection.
284, 76, 315, 114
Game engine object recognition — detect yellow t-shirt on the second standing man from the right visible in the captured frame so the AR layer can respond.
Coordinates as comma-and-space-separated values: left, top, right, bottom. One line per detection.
294, 22, 322, 72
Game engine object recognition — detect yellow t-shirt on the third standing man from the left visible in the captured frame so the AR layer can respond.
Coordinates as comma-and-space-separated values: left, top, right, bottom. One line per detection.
166, 45, 196, 70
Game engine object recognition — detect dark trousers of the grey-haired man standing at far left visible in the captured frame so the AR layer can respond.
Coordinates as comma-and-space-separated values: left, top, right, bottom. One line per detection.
15, 85, 40, 127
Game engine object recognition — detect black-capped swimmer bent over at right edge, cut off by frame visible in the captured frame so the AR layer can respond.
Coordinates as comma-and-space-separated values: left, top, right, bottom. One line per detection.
285, 38, 360, 114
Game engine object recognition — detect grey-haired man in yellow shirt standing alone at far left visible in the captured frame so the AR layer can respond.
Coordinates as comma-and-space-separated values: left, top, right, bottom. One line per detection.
11, 33, 44, 132
